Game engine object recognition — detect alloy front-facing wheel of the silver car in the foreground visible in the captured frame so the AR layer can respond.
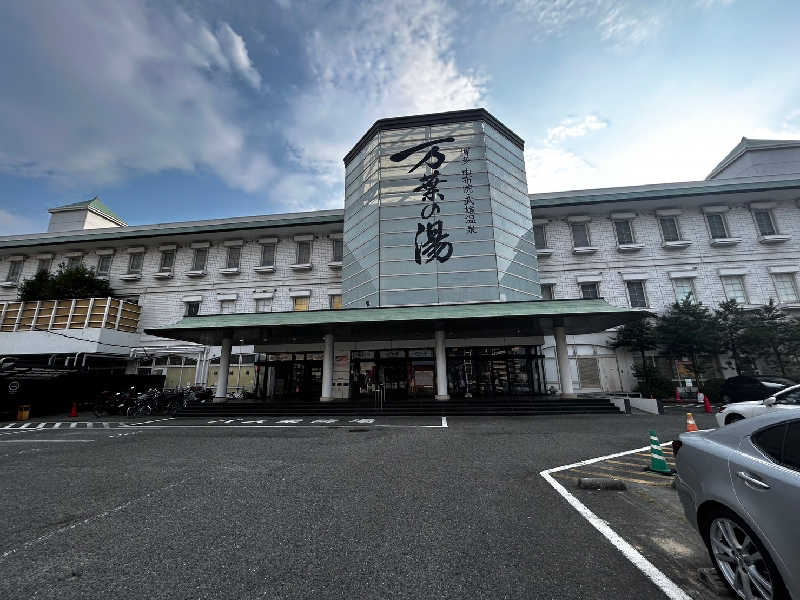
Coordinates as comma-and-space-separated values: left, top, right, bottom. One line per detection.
703, 508, 789, 600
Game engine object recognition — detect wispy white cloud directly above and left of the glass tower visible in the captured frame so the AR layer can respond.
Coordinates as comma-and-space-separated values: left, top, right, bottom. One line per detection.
278, 0, 484, 206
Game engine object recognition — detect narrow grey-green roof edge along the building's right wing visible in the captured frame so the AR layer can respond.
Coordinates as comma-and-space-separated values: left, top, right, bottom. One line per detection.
528, 175, 800, 209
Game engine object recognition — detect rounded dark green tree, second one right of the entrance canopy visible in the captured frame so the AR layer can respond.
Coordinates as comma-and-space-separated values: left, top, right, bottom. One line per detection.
655, 294, 721, 382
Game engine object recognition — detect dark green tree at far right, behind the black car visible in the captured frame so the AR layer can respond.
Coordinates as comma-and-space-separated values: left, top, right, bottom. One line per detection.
742, 298, 800, 377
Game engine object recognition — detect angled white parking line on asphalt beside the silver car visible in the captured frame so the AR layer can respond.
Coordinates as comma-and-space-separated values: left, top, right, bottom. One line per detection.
539, 442, 692, 600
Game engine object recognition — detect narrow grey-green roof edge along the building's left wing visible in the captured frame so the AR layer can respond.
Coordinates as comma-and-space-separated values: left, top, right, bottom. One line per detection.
0, 209, 344, 249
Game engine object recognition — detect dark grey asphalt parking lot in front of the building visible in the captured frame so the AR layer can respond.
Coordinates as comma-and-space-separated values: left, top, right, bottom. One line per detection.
0, 411, 713, 599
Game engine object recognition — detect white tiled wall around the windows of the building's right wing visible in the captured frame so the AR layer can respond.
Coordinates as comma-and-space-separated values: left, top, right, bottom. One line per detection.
534, 202, 800, 311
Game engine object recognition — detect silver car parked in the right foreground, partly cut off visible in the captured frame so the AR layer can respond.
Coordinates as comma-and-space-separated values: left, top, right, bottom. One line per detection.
673, 411, 800, 600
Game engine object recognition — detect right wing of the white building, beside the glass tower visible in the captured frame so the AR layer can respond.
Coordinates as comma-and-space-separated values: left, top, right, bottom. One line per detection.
530, 138, 800, 391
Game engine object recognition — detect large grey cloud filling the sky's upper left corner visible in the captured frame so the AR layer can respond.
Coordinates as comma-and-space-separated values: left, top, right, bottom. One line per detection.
0, 0, 275, 191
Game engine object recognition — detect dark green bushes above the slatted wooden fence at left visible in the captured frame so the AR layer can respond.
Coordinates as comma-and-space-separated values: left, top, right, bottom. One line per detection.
18, 263, 114, 302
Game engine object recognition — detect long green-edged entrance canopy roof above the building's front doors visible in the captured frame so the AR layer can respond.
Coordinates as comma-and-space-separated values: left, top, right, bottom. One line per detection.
145, 300, 650, 346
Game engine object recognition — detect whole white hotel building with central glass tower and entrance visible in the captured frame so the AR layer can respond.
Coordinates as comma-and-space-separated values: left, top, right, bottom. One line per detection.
0, 111, 800, 399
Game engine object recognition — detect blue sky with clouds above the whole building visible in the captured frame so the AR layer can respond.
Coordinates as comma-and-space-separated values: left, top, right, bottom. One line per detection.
0, 0, 800, 235
